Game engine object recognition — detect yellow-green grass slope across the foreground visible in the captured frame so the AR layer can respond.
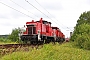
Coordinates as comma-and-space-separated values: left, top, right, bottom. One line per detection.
1, 42, 90, 60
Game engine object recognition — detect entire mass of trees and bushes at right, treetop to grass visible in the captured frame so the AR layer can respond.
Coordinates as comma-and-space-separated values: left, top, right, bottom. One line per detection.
71, 11, 90, 50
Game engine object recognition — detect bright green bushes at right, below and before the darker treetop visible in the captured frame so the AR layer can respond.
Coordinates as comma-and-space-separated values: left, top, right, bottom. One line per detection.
71, 23, 90, 50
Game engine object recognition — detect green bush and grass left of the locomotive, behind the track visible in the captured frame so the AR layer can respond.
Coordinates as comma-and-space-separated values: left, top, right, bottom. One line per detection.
0, 28, 22, 43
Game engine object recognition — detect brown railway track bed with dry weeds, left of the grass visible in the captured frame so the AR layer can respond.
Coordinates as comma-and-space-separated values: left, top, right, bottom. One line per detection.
0, 44, 43, 56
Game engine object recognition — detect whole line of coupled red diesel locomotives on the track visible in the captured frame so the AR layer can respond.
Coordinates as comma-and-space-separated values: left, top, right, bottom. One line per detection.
21, 18, 65, 44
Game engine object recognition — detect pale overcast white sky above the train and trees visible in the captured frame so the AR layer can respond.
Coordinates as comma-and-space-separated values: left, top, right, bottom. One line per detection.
0, 0, 90, 37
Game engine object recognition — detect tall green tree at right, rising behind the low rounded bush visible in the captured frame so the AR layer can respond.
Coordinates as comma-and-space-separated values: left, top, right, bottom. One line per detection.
71, 11, 90, 41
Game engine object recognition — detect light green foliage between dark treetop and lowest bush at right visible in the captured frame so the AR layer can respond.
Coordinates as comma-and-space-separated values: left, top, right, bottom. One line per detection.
71, 23, 90, 41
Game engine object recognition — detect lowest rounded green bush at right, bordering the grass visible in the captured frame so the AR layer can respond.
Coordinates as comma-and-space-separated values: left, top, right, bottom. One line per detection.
74, 33, 90, 49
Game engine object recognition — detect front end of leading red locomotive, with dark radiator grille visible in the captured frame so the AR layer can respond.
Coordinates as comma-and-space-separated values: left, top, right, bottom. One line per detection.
21, 20, 41, 43
